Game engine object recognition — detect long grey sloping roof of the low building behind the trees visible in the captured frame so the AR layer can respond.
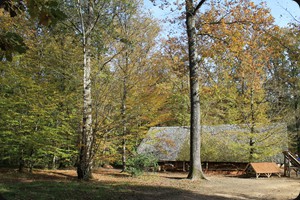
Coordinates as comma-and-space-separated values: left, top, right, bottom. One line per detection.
137, 124, 287, 162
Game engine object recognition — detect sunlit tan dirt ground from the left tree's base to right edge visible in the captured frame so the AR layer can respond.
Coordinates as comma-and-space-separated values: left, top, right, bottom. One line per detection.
95, 169, 300, 200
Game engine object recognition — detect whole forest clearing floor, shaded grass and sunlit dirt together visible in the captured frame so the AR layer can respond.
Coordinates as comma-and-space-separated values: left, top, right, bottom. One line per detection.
0, 168, 300, 200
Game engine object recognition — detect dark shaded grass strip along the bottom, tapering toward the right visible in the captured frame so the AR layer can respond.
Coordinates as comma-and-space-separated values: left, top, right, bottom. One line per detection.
0, 181, 262, 200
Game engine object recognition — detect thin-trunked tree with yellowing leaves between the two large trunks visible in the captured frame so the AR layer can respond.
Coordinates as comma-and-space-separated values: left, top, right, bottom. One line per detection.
115, 7, 159, 171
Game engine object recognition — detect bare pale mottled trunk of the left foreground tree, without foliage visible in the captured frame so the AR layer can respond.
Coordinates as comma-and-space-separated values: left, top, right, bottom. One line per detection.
77, 0, 94, 180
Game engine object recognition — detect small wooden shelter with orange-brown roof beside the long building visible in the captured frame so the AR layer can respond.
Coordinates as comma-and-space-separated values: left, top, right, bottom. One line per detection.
245, 162, 281, 178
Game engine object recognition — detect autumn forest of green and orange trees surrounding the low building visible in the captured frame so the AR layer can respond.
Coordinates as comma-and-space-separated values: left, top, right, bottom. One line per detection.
0, 0, 300, 179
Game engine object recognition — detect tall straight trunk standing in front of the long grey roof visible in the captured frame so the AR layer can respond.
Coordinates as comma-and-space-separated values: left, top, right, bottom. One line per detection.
186, 0, 205, 180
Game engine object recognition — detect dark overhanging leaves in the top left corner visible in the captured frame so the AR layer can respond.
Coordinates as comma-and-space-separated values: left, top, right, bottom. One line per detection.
0, 0, 67, 61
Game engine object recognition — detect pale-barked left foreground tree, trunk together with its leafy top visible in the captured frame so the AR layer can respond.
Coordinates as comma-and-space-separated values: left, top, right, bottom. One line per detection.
64, 0, 121, 180
